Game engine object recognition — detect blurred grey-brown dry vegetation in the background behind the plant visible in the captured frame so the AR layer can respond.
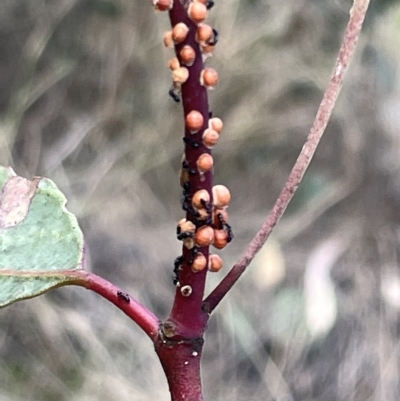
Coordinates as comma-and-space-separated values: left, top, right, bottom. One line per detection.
0, 0, 400, 401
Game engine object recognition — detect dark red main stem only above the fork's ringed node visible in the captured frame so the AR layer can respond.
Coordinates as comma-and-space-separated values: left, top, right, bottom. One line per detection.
161, 0, 212, 339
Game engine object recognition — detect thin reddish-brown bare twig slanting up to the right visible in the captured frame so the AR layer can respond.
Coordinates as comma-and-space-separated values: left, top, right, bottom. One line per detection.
204, 0, 369, 313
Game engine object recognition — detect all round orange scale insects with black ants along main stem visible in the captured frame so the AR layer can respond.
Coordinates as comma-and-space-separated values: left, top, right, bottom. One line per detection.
153, 0, 233, 288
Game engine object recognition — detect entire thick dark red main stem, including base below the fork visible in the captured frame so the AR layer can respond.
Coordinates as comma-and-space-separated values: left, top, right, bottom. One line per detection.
155, 0, 213, 401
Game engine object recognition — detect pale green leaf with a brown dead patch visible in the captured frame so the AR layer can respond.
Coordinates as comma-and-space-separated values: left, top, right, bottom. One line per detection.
0, 167, 84, 307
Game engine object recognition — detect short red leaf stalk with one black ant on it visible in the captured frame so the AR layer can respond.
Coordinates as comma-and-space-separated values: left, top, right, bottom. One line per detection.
67, 270, 160, 341
